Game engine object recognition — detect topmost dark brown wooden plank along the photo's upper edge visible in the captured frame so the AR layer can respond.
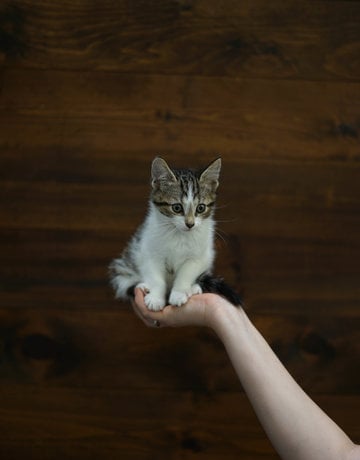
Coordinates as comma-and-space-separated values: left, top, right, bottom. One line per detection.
1, 0, 360, 80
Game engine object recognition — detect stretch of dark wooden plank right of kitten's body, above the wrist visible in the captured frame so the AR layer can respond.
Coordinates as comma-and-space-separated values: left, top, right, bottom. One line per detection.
217, 234, 360, 317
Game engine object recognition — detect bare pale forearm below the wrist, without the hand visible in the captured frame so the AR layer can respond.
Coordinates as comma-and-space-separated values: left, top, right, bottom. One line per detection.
213, 308, 354, 460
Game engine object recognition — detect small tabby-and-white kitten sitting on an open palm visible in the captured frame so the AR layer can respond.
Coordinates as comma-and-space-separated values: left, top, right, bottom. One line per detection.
110, 157, 240, 311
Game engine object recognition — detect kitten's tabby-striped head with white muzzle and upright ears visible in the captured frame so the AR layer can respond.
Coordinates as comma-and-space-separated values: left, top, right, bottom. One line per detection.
151, 157, 221, 231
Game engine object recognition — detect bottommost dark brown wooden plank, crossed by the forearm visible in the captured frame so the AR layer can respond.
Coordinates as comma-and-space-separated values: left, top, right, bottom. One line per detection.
0, 386, 360, 460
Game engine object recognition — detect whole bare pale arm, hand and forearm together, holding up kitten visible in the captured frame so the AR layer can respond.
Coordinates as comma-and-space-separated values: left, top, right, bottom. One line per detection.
133, 289, 360, 460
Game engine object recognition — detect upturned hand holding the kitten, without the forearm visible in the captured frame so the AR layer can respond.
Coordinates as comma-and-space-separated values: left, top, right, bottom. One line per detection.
132, 288, 230, 327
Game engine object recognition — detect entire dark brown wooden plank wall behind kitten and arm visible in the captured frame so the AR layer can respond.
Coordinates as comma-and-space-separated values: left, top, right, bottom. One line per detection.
0, 0, 360, 460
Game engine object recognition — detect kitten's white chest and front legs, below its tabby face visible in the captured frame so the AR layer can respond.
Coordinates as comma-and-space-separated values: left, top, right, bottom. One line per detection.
136, 208, 215, 310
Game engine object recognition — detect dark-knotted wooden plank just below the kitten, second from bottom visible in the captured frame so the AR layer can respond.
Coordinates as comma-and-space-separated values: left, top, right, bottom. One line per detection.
0, 308, 360, 396
